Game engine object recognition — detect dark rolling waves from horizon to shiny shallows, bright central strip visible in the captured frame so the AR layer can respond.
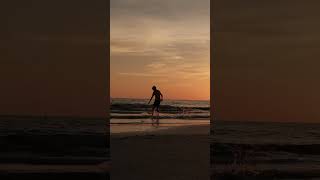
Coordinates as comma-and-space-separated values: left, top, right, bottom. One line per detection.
111, 98, 210, 120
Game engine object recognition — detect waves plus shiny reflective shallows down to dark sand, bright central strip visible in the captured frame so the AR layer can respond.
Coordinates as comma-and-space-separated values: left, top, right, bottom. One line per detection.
110, 98, 210, 134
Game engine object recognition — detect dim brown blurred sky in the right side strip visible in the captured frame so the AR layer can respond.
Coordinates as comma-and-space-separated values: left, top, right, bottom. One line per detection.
211, 0, 320, 122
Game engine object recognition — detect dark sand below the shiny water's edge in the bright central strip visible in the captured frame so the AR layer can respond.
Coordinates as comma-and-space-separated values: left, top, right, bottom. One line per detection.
110, 124, 210, 180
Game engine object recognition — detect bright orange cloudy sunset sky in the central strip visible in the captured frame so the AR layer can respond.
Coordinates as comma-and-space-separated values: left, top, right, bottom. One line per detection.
110, 0, 210, 100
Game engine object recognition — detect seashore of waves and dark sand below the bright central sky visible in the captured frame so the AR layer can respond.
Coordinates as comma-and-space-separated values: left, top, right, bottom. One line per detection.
110, 99, 210, 180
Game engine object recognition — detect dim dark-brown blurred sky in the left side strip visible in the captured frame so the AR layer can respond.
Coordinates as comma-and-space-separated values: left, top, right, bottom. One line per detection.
0, 0, 108, 117
